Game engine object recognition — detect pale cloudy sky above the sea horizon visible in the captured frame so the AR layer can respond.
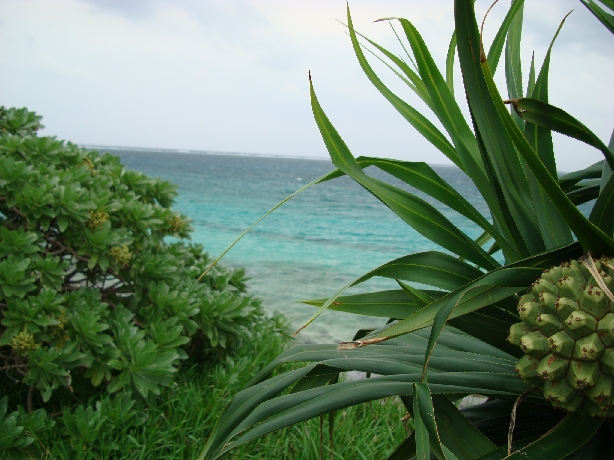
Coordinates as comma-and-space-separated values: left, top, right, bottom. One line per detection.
0, 0, 614, 171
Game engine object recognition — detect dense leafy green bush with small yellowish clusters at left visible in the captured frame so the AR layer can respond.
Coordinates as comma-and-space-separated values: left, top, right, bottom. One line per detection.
0, 107, 262, 451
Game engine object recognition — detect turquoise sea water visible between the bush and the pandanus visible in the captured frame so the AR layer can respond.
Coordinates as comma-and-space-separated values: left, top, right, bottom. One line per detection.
113, 151, 487, 343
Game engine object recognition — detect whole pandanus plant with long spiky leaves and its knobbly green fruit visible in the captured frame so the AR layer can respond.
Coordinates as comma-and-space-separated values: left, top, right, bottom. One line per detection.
201, 0, 614, 459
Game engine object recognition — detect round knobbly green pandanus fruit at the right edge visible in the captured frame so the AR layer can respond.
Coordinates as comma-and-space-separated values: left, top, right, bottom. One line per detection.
508, 257, 614, 417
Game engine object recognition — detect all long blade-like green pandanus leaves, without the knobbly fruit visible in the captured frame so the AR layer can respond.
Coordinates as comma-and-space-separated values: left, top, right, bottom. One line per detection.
201, 0, 614, 460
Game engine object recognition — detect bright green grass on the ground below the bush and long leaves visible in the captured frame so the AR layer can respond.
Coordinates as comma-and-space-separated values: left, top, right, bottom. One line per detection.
0, 310, 411, 460
